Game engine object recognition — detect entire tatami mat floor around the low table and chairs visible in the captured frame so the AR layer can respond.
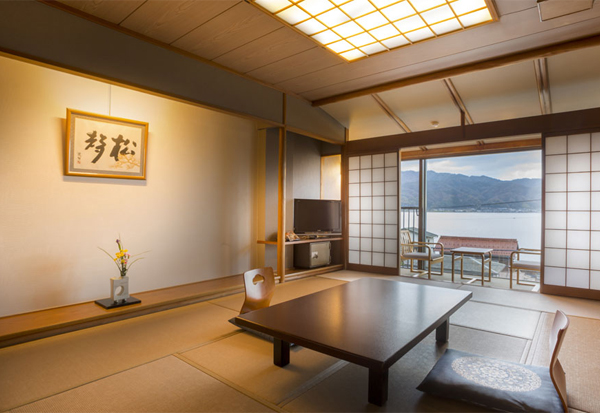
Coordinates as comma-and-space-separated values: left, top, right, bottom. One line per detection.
0, 271, 600, 412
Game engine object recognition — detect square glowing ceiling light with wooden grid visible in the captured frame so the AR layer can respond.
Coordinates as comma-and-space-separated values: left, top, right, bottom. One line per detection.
251, 0, 496, 61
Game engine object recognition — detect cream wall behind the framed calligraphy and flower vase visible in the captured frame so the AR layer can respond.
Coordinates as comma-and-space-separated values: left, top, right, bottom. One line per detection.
0, 57, 257, 316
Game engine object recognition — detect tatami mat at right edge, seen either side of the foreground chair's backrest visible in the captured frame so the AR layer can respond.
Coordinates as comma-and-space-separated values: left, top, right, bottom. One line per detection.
531, 313, 600, 412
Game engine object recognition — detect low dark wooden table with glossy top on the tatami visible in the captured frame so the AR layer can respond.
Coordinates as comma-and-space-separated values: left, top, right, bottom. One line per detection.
236, 278, 472, 406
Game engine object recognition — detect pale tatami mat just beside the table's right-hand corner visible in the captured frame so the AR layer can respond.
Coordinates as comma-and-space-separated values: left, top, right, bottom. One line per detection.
450, 301, 540, 339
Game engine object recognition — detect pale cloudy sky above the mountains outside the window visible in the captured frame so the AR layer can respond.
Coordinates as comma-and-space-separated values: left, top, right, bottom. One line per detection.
402, 150, 542, 181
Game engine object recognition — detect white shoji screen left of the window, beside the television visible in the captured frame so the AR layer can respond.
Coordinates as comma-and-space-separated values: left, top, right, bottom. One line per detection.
348, 152, 399, 274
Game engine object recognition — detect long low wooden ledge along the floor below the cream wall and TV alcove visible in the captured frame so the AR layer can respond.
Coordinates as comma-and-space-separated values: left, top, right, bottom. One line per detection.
0, 265, 344, 348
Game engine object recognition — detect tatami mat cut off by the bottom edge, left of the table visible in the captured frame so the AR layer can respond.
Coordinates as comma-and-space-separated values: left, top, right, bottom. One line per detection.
13, 356, 273, 413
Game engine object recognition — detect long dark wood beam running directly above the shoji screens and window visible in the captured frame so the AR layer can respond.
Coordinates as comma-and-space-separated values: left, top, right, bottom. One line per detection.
346, 108, 600, 156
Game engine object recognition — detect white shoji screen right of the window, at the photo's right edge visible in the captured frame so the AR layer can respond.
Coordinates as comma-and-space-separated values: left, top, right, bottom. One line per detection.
542, 133, 600, 297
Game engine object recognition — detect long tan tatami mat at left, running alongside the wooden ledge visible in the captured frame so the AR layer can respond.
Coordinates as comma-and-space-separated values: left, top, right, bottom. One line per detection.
0, 303, 237, 411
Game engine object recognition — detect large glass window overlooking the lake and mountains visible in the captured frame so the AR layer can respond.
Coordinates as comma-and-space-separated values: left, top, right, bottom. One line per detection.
401, 150, 542, 289
